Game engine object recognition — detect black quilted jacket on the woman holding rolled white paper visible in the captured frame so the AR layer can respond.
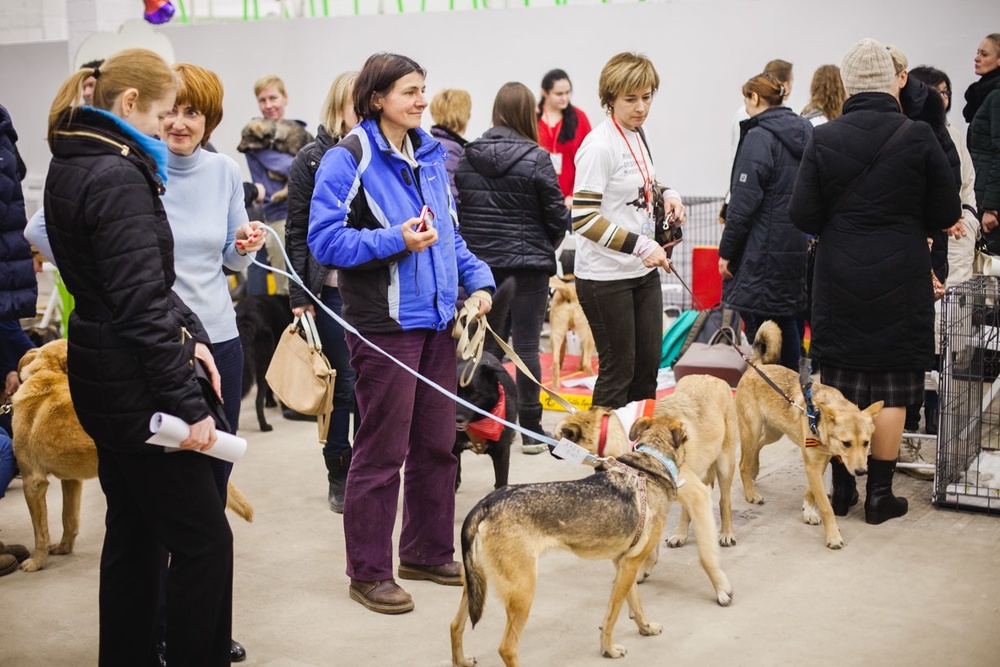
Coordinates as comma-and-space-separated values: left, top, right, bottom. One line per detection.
45, 109, 209, 452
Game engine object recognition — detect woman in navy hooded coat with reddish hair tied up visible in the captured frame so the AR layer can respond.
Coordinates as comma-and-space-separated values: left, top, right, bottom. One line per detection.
719, 74, 812, 371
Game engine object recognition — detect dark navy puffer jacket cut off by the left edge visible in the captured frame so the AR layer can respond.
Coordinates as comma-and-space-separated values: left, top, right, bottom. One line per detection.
0, 106, 38, 320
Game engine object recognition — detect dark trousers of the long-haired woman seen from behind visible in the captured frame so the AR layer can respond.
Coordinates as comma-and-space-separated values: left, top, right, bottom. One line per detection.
484, 269, 549, 431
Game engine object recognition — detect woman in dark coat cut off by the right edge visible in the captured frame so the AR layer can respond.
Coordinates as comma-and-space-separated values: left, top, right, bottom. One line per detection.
962, 32, 1000, 241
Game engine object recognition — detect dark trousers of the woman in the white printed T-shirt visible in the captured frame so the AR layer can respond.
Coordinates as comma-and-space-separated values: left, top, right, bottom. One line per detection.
576, 270, 663, 409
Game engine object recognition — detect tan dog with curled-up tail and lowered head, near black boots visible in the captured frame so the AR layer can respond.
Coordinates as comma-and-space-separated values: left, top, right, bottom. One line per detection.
736, 321, 883, 549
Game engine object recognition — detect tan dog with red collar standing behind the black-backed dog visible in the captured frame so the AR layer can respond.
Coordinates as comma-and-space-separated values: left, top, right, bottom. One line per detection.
555, 375, 737, 606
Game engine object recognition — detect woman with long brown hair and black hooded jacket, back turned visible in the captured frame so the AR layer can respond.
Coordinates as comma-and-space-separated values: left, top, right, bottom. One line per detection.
455, 83, 570, 454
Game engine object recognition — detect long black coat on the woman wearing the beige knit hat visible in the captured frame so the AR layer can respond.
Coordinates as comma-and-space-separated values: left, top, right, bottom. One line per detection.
788, 93, 960, 371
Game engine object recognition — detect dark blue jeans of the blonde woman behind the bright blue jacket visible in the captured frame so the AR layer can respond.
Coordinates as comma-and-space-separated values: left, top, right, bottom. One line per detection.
316, 285, 360, 456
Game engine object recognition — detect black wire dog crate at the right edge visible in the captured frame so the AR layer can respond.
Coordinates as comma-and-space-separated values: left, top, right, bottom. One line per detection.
933, 276, 1000, 513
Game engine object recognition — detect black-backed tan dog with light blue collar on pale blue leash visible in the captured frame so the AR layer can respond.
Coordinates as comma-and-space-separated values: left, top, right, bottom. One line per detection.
451, 417, 685, 667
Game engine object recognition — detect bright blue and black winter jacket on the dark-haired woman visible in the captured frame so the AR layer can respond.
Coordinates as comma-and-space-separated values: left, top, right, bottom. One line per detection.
306, 120, 495, 333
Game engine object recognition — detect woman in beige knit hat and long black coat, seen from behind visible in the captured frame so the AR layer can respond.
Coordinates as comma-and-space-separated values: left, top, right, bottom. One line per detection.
788, 39, 960, 524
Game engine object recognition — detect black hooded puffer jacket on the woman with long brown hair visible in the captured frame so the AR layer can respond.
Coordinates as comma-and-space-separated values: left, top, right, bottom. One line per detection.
455, 127, 570, 275
